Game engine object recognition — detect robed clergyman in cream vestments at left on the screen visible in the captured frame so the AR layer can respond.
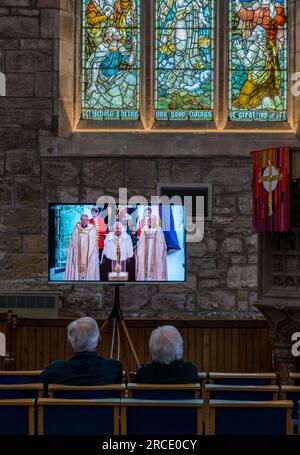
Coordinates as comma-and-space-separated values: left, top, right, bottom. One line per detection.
65, 215, 100, 281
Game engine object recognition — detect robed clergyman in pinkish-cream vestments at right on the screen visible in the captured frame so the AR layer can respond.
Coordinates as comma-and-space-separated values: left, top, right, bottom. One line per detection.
135, 215, 167, 281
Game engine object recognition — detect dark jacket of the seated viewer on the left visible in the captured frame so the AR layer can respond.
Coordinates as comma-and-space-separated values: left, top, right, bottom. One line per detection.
40, 351, 122, 385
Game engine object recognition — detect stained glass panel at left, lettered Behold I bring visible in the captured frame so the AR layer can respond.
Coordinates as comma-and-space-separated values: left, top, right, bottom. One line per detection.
81, 0, 140, 120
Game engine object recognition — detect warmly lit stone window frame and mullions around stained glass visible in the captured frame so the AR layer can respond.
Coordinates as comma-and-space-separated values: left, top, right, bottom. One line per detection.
57, 0, 300, 137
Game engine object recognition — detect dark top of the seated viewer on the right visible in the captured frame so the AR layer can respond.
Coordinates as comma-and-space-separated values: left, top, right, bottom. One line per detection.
134, 360, 199, 384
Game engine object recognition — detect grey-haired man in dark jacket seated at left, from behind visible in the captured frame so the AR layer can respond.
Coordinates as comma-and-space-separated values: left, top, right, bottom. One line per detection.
40, 317, 122, 385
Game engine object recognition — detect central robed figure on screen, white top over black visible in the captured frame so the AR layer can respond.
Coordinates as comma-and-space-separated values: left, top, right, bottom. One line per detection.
100, 221, 135, 281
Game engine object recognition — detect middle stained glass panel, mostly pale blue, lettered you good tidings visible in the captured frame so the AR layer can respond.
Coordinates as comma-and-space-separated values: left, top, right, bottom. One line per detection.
155, 0, 214, 120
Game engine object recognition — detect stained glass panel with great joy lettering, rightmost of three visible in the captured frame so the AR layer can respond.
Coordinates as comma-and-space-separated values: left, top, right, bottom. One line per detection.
229, 0, 288, 121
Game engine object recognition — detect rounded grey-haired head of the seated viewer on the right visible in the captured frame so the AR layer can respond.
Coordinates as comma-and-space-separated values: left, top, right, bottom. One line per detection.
149, 325, 183, 365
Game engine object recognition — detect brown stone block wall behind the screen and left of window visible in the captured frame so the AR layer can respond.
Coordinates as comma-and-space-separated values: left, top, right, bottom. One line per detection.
0, 0, 297, 319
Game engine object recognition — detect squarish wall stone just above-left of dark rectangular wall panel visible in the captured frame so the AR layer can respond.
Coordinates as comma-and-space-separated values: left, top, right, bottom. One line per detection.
125, 159, 157, 188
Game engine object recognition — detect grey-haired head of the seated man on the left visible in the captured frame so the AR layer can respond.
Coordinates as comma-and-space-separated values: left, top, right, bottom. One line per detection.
67, 317, 100, 352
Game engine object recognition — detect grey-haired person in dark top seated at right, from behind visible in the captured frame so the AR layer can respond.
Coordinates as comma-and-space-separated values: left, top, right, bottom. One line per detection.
134, 325, 199, 384
